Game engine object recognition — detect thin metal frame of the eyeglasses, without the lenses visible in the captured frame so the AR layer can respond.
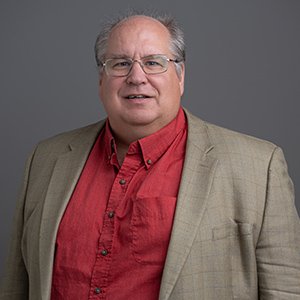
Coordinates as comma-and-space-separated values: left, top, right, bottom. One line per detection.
101, 54, 182, 77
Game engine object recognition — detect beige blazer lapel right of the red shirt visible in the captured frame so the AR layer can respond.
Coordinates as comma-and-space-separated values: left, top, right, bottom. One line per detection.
159, 111, 217, 300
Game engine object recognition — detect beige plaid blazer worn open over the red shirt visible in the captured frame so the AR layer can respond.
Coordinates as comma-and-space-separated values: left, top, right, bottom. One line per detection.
0, 112, 300, 300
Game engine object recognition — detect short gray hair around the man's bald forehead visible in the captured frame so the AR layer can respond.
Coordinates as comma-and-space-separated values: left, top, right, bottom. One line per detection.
94, 12, 185, 76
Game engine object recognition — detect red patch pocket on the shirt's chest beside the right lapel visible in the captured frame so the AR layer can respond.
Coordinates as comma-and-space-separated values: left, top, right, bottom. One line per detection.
130, 196, 176, 265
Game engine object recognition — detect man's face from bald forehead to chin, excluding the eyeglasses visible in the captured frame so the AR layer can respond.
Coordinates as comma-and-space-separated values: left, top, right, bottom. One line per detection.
99, 16, 184, 137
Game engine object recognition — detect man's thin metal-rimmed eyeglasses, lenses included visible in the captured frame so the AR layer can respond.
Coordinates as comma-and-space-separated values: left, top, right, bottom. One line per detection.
102, 55, 180, 77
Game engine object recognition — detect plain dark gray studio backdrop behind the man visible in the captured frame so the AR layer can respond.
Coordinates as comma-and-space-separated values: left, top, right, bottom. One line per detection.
0, 0, 300, 271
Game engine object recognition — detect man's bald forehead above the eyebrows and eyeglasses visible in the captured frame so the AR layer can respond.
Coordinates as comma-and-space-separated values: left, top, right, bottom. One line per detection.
106, 16, 170, 57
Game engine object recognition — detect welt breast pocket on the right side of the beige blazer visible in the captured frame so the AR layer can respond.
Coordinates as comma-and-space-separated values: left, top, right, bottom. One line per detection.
212, 220, 253, 240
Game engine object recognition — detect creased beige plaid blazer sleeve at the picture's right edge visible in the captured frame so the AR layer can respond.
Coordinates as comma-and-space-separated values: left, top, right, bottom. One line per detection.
256, 148, 300, 300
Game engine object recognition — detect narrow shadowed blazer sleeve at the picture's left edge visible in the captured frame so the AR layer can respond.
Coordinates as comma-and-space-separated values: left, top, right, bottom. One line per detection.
0, 152, 34, 300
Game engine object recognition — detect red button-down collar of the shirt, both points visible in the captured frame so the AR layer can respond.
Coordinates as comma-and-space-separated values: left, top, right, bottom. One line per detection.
104, 107, 186, 169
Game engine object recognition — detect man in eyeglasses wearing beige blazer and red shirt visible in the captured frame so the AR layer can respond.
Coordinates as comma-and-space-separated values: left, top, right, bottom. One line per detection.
0, 11, 300, 300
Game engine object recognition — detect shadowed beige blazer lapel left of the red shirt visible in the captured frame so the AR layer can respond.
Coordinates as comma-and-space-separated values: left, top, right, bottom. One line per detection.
39, 123, 103, 299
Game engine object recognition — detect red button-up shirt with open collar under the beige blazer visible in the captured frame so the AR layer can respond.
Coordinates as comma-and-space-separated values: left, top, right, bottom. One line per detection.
51, 109, 187, 300
